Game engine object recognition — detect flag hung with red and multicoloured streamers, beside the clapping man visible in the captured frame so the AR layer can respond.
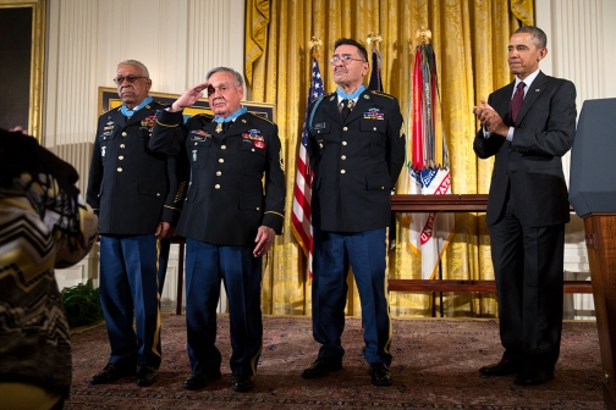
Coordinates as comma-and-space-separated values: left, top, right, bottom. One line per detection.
407, 42, 455, 279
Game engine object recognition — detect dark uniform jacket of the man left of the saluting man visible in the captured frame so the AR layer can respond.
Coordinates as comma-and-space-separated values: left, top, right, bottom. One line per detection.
86, 102, 188, 235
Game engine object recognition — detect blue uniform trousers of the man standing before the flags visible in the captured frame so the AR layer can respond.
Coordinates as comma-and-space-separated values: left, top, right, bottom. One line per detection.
312, 228, 391, 366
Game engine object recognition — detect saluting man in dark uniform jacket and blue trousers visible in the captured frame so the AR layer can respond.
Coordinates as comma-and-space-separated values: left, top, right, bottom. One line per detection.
150, 67, 285, 392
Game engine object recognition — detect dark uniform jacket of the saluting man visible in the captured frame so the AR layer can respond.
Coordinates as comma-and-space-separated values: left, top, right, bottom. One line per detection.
150, 110, 285, 247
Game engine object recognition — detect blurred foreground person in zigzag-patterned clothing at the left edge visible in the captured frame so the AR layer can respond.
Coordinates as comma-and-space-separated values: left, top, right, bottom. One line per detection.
0, 130, 97, 410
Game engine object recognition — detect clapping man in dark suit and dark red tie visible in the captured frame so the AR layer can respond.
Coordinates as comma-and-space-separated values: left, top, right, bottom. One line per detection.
473, 27, 576, 386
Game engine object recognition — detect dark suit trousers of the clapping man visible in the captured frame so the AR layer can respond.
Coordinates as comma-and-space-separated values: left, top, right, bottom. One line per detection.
488, 189, 565, 370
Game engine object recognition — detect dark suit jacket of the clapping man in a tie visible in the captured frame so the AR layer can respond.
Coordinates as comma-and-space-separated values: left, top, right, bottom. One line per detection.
473, 72, 577, 227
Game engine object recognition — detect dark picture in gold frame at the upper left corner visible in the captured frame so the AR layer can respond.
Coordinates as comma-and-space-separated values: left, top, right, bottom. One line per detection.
0, 0, 46, 142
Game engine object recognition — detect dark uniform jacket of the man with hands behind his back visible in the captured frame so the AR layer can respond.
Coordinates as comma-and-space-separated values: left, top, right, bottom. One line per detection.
308, 90, 405, 233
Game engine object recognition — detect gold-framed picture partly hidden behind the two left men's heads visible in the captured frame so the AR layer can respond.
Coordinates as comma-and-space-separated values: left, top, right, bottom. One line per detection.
98, 87, 276, 122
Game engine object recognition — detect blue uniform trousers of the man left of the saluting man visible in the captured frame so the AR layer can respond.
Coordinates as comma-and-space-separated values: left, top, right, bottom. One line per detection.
99, 235, 164, 370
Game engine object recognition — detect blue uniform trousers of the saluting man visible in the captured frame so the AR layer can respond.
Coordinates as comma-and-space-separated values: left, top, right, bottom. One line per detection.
186, 239, 263, 376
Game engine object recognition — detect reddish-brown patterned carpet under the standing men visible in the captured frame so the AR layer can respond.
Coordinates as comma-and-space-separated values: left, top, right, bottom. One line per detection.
65, 315, 604, 410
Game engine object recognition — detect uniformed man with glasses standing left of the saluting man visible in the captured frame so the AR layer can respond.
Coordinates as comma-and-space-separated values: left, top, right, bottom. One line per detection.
86, 60, 187, 386
